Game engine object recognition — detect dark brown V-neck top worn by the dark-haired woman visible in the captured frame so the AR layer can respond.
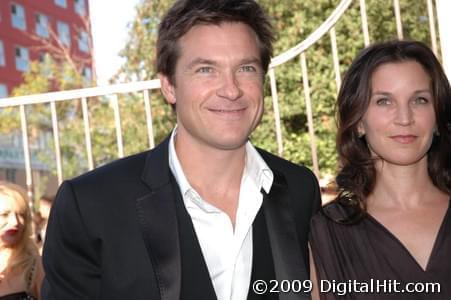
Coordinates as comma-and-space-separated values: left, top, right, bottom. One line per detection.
310, 203, 451, 300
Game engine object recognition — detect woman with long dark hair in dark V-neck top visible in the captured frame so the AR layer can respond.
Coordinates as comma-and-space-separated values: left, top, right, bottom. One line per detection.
310, 41, 451, 299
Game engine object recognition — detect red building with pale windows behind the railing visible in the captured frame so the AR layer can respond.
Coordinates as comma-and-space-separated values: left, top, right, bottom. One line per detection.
0, 0, 93, 98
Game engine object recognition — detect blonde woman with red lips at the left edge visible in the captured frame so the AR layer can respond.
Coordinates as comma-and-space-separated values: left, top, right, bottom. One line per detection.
0, 182, 44, 300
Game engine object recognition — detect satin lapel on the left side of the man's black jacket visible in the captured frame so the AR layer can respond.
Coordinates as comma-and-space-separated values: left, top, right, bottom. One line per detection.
136, 184, 181, 300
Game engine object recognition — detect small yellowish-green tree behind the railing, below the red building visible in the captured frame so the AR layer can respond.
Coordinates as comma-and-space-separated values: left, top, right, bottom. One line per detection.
0, 55, 91, 203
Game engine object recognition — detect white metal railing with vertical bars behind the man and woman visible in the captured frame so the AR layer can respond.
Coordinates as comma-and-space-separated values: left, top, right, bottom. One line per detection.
0, 0, 444, 202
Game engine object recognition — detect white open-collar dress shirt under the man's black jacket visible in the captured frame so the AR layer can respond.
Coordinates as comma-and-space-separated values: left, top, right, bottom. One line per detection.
169, 129, 274, 300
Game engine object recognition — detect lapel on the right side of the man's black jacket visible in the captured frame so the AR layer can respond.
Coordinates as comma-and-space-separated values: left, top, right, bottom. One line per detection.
263, 173, 310, 300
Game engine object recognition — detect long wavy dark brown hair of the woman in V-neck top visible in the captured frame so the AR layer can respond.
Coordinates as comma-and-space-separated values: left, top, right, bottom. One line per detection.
325, 41, 451, 223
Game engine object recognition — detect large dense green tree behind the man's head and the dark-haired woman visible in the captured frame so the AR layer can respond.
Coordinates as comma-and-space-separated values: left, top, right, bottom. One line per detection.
115, 0, 436, 175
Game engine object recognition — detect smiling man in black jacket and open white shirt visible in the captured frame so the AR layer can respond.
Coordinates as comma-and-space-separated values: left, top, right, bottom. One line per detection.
43, 0, 320, 300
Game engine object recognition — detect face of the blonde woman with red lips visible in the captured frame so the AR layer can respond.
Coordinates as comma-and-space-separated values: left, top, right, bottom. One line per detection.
0, 194, 25, 248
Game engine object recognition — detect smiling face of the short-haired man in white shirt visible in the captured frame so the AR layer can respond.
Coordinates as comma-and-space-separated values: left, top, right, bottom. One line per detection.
160, 22, 264, 150
